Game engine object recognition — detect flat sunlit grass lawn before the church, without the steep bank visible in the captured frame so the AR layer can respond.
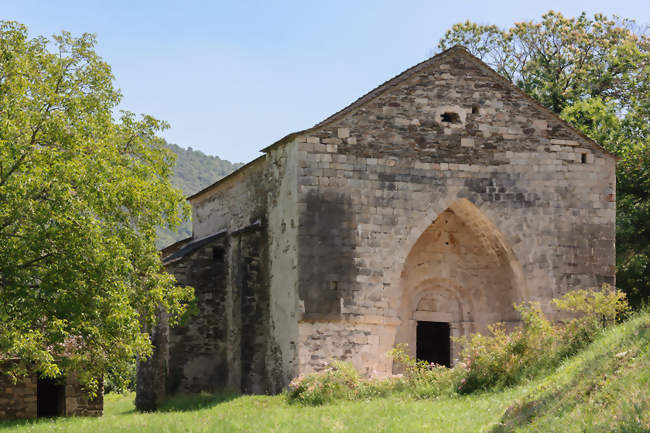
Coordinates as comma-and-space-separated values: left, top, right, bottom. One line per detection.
0, 387, 526, 433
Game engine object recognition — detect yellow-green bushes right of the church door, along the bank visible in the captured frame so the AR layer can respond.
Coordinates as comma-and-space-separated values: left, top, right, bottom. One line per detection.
457, 286, 628, 393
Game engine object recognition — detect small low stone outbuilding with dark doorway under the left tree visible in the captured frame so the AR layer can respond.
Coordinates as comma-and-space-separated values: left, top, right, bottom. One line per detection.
0, 360, 104, 420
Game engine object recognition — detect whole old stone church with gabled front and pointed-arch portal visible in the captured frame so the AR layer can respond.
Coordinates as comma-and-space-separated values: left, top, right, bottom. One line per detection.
137, 47, 616, 408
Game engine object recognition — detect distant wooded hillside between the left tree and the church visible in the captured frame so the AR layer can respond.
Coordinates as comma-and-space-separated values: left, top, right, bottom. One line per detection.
156, 143, 244, 248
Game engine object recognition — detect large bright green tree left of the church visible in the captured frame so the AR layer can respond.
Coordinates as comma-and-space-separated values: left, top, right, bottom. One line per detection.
0, 21, 192, 391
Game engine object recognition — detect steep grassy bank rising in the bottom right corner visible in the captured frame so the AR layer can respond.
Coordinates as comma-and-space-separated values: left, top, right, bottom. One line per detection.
493, 313, 650, 433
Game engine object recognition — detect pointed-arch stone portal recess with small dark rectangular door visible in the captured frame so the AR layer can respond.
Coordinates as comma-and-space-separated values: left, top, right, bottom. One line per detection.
395, 199, 526, 365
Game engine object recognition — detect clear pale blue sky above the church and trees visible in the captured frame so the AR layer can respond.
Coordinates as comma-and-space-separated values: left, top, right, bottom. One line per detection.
0, 0, 650, 162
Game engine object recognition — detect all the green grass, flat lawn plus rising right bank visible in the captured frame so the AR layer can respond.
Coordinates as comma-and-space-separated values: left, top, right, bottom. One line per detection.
0, 313, 650, 433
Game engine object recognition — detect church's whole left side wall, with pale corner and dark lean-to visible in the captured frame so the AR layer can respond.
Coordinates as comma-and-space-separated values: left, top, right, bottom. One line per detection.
138, 142, 297, 407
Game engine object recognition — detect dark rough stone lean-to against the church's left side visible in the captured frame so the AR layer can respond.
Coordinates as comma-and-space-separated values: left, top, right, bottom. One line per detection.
159, 225, 278, 394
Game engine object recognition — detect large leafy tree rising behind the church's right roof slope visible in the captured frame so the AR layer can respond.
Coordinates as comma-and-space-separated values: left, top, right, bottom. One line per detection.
438, 11, 650, 304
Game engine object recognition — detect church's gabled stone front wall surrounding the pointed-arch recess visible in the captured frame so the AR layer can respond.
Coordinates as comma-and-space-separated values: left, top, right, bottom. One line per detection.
298, 52, 615, 375
